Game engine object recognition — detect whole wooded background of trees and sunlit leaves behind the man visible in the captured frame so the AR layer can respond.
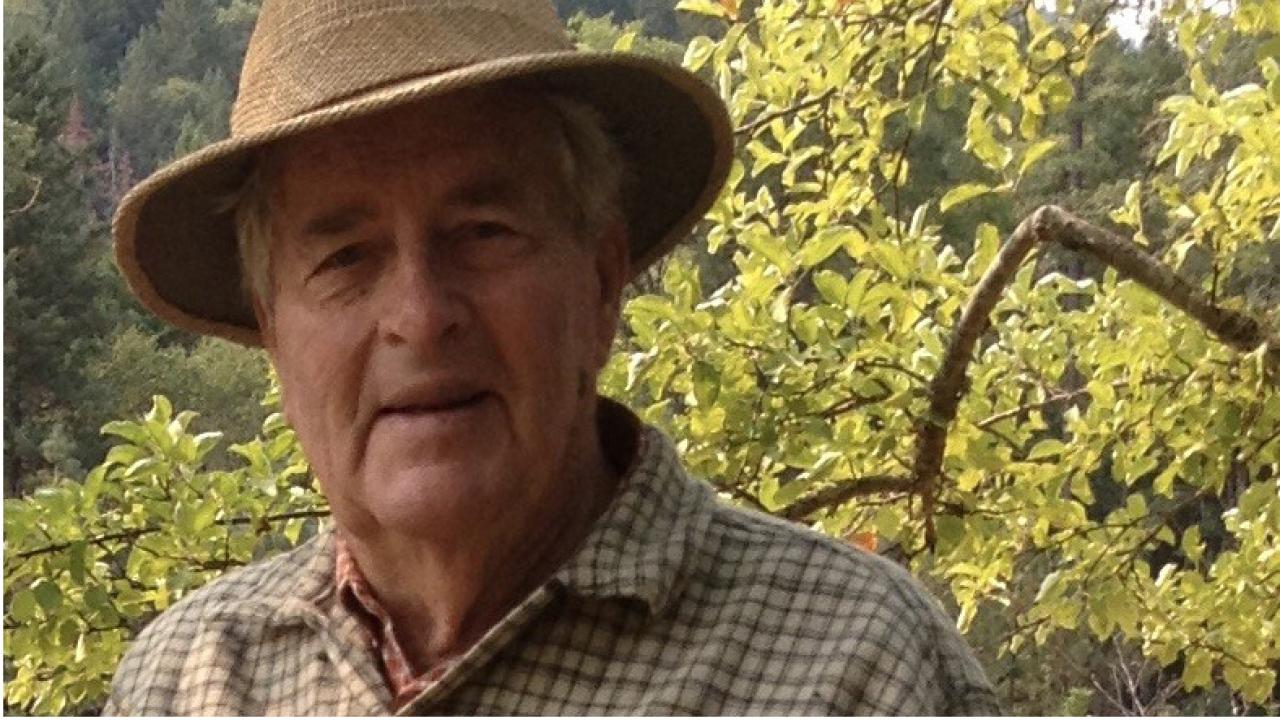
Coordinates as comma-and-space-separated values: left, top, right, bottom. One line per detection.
4, 0, 1280, 714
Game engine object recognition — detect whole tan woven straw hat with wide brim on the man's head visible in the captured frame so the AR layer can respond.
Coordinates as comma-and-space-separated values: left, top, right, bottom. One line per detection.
113, 0, 732, 345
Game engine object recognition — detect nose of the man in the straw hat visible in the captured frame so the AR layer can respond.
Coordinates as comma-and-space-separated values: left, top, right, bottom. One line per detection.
379, 252, 468, 347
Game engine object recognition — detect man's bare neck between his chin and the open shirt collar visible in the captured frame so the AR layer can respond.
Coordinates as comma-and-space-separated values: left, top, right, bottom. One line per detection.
346, 412, 618, 671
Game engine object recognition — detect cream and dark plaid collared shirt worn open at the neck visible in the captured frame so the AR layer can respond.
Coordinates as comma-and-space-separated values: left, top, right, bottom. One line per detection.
106, 409, 998, 715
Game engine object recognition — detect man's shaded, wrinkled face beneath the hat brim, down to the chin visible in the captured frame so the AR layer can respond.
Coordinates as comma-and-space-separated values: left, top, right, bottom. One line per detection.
260, 88, 626, 537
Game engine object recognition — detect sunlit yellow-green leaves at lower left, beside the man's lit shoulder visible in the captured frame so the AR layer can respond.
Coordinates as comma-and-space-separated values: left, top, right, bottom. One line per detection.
5, 396, 325, 714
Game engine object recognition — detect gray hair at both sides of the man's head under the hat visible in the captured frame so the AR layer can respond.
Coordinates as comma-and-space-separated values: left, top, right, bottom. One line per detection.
227, 94, 627, 309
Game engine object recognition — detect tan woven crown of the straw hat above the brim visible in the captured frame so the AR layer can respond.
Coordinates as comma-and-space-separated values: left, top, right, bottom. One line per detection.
230, 0, 573, 137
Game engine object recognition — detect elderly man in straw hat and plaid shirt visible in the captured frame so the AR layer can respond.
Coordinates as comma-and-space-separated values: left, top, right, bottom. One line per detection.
108, 0, 996, 715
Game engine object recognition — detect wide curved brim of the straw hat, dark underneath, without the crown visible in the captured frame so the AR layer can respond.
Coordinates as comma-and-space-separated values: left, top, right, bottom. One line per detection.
113, 51, 733, 346
